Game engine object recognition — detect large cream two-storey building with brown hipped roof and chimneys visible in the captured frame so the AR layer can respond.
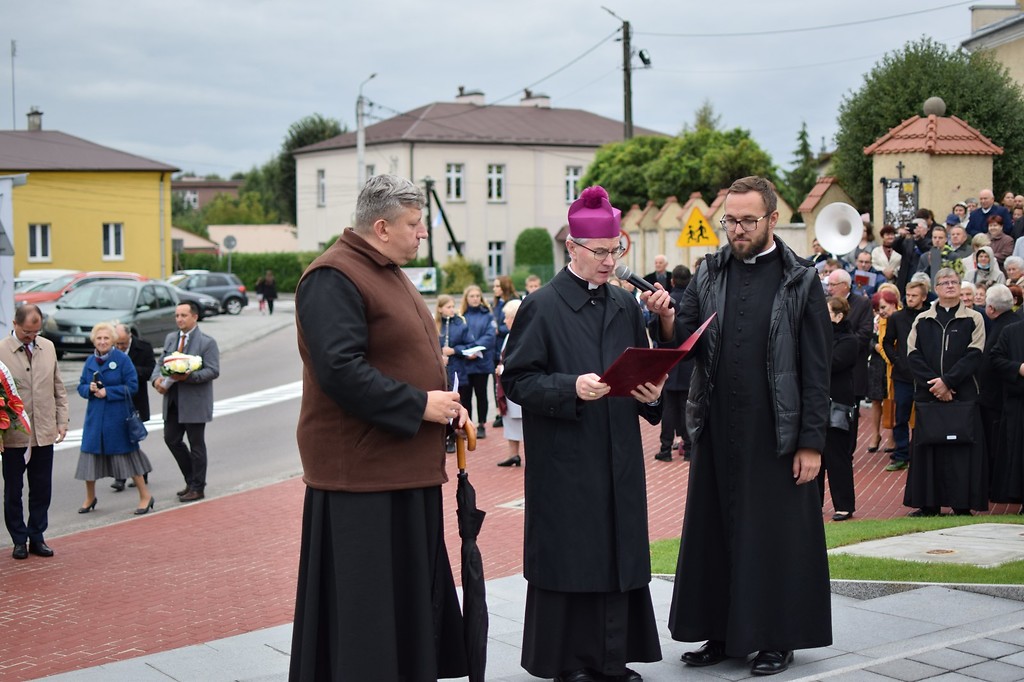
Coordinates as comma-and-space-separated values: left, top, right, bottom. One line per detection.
295, 93, 663, 279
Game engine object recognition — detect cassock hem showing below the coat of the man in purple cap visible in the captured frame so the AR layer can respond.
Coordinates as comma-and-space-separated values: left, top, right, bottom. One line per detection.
522, 585, 662, 677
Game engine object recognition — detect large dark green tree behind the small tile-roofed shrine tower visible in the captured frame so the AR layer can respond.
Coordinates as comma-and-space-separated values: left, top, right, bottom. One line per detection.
833, 38, 1024, 206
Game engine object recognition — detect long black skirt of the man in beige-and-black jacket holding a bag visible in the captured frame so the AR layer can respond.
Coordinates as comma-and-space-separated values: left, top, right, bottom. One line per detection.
903, 403, 988, 511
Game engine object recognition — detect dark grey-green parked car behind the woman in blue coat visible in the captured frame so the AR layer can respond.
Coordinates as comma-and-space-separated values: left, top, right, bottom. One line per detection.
42, 280, 178, 355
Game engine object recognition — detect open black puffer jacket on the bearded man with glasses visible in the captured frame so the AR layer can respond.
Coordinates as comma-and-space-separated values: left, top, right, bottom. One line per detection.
667, 237, 833, 457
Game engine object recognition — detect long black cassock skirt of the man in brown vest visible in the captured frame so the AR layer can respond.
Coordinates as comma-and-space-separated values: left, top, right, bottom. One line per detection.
289, 486, 467, 682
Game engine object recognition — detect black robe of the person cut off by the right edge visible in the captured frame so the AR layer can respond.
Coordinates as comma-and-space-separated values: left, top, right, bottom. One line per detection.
989, 313, 1024, 503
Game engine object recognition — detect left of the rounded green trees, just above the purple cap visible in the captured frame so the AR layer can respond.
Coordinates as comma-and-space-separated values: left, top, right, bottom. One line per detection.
580, 136, 672, 205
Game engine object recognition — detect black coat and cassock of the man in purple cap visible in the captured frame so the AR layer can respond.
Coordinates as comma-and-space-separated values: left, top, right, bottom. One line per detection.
502, 269, 662, 677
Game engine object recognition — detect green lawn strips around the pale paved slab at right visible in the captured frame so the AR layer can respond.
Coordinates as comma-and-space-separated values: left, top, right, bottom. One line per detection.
650, 514, 1024, 585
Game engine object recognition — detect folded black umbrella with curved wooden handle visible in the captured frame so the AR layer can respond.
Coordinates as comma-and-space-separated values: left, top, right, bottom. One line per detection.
455, 421, 487, 682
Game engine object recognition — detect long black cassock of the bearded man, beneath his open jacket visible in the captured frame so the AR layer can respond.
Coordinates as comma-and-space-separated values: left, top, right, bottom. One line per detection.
669, 247, 831, 656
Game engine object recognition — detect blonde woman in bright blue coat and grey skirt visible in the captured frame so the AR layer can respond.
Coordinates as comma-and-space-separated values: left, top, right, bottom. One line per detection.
75, 323, 154, 514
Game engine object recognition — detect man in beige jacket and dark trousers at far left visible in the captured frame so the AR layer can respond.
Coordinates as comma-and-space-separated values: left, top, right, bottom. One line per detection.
0, 303, 68, 559
